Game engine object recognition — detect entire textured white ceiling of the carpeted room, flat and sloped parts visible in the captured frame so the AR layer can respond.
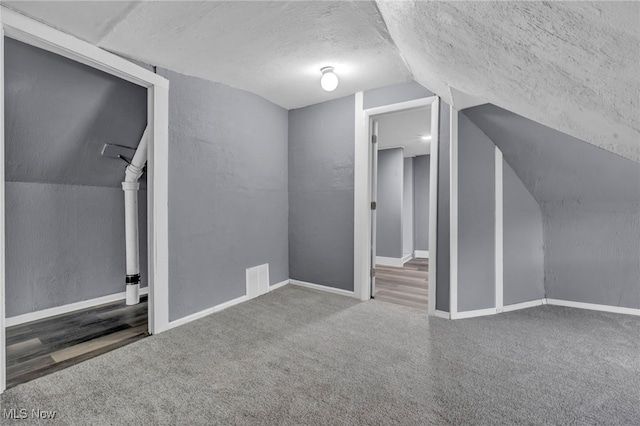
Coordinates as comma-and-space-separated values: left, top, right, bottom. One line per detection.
3, 1, 640, 162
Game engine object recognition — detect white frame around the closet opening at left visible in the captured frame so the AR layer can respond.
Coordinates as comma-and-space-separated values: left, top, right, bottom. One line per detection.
0, 6, 169, 393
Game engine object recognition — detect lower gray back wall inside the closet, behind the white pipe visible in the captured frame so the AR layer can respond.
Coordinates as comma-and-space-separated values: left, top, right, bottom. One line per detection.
5, 182, 147, 317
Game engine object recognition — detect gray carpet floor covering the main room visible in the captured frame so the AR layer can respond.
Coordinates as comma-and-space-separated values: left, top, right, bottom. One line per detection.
0, 285, 640, 425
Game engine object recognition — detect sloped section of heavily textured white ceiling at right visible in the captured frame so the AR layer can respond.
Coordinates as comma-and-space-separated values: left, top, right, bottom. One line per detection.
378, 1, 640, 161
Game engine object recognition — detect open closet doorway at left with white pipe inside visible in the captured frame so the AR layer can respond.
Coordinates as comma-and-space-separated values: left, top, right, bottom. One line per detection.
3, 38, 148, 387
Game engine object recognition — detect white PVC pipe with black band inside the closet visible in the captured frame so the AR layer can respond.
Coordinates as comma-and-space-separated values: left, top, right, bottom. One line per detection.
122, 128, 148, 305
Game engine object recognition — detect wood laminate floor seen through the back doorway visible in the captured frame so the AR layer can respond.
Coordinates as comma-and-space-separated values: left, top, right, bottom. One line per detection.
375, 258, 429, 310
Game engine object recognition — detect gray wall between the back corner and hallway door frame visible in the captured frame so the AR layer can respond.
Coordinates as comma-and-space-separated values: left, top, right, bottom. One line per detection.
289, 96, 355, 290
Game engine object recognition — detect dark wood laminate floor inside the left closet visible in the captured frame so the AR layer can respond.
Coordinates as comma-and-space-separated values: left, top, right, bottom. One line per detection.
6, 295, 148, 388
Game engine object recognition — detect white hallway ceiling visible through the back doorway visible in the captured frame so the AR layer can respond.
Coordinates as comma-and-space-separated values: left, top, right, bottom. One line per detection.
375, 107, 431, 157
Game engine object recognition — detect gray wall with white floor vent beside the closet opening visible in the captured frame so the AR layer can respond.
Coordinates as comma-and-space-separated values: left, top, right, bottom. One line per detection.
158, 69, 289, 320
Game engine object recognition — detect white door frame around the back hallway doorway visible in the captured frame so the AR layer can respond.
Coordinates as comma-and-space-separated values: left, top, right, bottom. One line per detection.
353, 92, 440, 315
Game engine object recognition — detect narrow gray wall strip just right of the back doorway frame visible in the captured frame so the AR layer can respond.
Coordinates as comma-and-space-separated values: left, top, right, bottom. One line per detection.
436, 99, 451, 312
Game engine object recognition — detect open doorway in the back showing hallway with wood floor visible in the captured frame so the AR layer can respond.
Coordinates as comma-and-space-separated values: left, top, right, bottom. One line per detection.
371, 106, 432, 311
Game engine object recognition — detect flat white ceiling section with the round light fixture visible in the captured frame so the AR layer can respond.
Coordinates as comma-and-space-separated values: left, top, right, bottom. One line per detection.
5, 1, 412, 109
